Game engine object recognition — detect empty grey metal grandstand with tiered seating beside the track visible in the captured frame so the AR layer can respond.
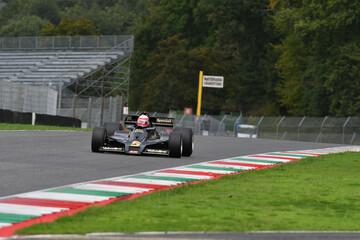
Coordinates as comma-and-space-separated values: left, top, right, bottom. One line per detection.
0, 35, 134, 127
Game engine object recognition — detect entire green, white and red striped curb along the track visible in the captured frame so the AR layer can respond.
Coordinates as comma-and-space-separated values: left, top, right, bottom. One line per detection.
0, 146, 360, 237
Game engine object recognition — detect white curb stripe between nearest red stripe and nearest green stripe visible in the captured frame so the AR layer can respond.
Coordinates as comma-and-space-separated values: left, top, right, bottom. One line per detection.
0, 203, 69, 216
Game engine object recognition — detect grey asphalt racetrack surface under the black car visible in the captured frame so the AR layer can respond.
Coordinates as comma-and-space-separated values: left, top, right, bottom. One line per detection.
0, 131, 344, 197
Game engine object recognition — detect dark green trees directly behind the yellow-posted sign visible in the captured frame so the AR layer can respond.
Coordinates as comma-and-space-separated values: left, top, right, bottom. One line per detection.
130, 0, 277, 113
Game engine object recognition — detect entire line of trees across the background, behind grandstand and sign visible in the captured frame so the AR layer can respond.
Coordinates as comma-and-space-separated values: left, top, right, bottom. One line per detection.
0, 0, 360, 116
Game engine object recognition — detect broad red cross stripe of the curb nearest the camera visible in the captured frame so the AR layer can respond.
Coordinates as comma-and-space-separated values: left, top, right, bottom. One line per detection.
0, 197, 89, 209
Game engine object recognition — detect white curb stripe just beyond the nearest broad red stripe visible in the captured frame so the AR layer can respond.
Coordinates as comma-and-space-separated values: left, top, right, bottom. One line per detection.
18, 191, 109, 203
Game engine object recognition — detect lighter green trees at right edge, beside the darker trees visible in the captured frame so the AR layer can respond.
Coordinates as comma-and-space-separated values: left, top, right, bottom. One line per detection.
273, 0, 360, 116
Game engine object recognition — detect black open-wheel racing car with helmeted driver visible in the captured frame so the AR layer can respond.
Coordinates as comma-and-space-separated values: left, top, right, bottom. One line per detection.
91, 112, 194, 158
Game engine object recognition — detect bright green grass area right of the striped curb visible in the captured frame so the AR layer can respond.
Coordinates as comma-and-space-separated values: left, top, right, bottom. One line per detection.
17, 153, 360, 234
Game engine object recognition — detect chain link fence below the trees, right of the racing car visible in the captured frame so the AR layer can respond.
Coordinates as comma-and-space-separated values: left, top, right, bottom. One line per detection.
124, 111, 360, 145
